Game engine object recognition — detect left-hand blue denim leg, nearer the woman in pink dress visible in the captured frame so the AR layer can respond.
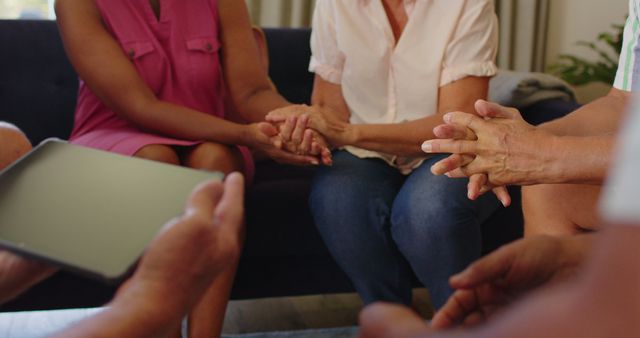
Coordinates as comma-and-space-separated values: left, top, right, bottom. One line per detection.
309, 151, 412, 304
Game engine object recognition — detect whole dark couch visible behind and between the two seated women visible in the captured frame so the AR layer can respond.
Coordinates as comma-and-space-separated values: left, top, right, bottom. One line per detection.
0, 20, 576, 311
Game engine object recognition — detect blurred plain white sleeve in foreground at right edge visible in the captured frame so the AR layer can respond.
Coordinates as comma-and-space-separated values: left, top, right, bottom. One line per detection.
600, 96, 640, 224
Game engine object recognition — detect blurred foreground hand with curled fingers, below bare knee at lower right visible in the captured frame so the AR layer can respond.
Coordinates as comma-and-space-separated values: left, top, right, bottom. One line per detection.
431, 235, 591, 329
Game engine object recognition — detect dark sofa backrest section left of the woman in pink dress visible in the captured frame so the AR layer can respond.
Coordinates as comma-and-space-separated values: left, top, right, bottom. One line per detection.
0, 20, 78, 144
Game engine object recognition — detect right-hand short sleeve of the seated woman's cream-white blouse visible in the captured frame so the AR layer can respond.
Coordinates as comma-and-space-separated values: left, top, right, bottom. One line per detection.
440, 0, 498, 86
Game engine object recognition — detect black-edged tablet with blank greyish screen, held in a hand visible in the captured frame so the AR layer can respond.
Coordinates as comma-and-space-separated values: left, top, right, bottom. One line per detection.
0, 140, 223, 283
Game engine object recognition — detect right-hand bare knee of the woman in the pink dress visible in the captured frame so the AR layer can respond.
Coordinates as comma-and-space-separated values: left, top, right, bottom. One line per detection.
184, 142, 244, 174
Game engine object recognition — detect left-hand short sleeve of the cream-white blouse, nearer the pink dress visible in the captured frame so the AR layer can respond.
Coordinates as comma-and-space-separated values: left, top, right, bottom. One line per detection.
309, 0, 345, 84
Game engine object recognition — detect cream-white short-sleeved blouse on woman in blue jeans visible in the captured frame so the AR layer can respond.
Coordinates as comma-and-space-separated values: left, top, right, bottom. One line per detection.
309, 0, 498, 173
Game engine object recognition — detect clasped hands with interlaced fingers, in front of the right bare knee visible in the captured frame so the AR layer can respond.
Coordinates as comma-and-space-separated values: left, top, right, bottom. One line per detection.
422, 100, 554, 190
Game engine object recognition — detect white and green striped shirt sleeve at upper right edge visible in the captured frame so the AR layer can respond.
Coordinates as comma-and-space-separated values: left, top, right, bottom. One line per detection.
613, 0, 640, 91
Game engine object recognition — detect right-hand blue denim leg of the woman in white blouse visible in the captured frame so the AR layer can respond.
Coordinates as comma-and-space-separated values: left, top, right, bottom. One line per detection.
391, 155, 499, 308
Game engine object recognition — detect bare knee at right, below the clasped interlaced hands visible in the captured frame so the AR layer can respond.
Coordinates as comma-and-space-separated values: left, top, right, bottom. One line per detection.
522, 184, 600, 236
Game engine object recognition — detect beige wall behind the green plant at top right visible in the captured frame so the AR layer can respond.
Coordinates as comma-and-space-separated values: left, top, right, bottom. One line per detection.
546, 0, 629, 102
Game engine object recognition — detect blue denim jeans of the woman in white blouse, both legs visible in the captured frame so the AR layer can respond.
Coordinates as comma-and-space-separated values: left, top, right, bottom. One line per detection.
310, 151, 499, 308
